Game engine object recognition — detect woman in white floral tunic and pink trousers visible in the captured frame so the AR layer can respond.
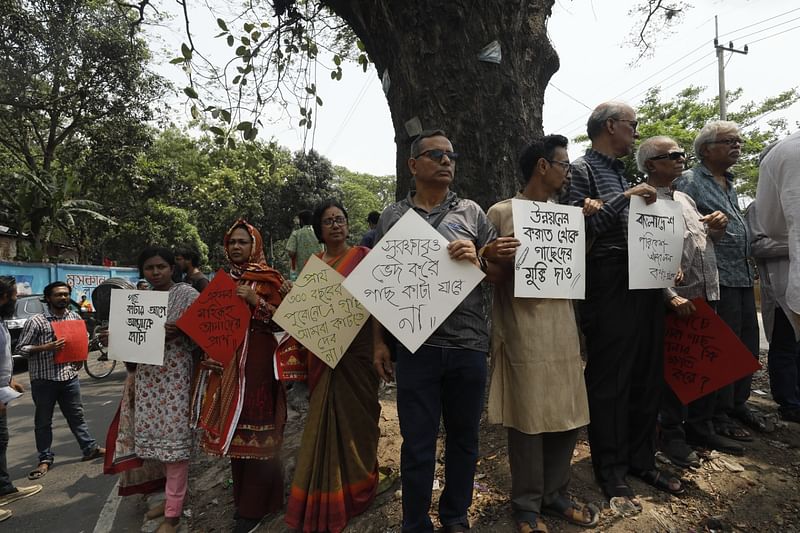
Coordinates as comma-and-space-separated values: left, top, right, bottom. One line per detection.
105, 247, 198, 533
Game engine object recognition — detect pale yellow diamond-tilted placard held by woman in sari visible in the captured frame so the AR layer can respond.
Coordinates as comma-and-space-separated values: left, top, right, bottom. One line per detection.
272, 255, 369, 368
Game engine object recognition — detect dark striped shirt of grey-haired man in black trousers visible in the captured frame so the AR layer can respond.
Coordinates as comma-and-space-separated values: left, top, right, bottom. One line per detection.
565, 148, 630, 257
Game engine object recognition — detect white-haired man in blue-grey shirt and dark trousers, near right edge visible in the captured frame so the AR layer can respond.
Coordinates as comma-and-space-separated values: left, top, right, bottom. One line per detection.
674, 120, 773, 442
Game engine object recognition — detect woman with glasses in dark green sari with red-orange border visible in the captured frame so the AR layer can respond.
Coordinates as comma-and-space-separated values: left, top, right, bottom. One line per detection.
286, 200, 381, 533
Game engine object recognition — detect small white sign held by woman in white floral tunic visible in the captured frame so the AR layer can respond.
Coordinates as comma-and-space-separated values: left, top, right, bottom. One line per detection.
108, 290, 169, 366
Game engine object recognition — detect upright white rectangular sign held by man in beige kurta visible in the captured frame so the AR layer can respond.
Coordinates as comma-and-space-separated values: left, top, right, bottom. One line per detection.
511, 198, 586, 300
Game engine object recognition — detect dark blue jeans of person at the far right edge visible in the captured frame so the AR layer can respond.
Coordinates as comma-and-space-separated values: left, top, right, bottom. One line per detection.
769, 306, 800, 411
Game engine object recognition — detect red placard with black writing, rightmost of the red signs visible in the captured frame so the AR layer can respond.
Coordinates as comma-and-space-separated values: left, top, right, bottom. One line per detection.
664, 298, 761, 404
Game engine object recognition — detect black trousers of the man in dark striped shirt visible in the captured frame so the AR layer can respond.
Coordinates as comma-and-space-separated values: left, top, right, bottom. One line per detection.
581, 256, 665, 496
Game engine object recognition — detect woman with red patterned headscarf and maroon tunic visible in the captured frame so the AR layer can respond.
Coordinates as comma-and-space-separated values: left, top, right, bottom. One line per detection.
195, 219, 286, 533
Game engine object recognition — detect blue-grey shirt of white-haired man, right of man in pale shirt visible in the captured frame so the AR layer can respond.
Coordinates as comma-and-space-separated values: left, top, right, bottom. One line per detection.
672, 164, 753, 287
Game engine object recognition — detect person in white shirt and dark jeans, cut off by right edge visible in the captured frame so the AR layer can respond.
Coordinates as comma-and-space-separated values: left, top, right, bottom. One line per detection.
753, 131, 800, 422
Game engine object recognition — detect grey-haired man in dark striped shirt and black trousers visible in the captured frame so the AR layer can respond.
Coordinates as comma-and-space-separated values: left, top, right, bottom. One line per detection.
567, 102, 668, 513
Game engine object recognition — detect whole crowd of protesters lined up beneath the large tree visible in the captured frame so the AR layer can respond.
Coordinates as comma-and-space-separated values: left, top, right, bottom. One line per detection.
0, 102, 800, 533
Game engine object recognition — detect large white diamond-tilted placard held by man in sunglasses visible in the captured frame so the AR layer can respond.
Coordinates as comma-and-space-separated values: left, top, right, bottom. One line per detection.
343, 209, 484, 353
